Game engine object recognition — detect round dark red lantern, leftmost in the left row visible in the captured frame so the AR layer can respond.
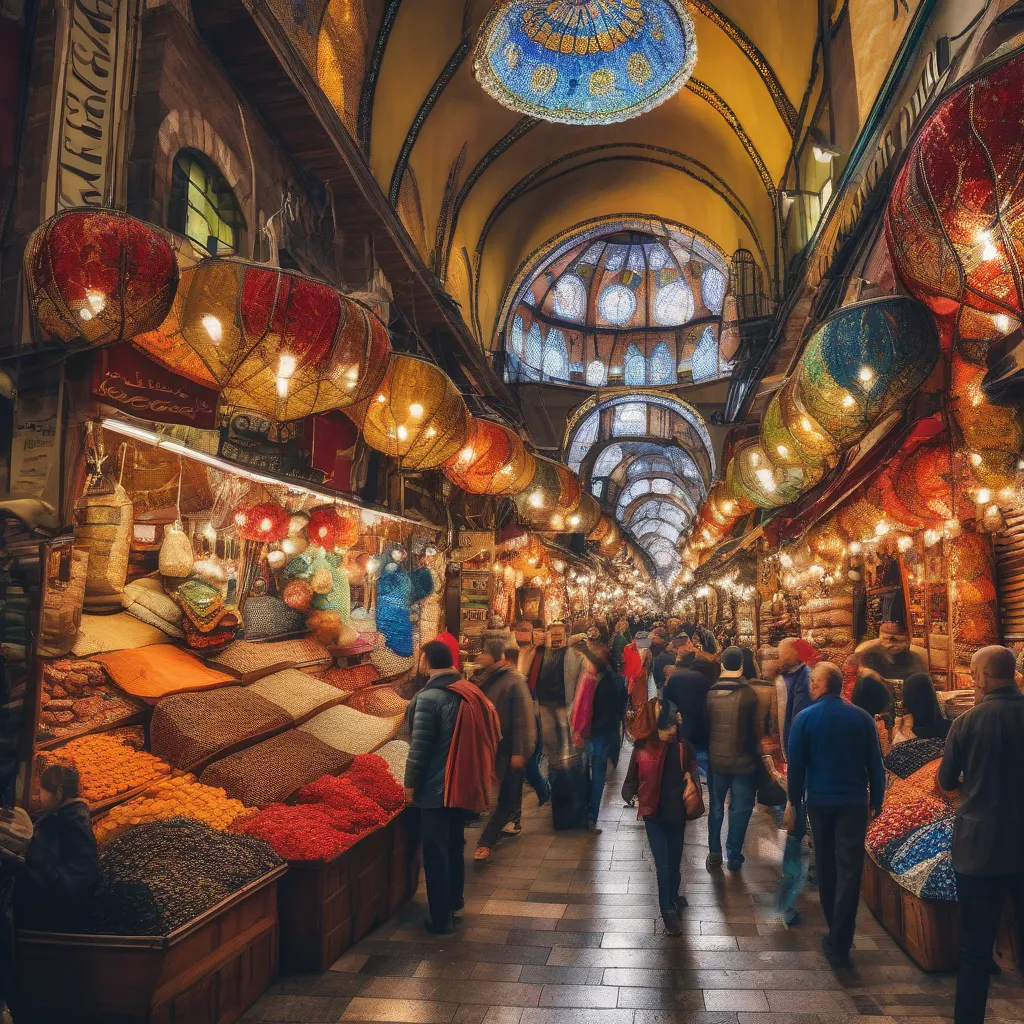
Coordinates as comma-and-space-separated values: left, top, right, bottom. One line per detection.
25, 210, 178, 346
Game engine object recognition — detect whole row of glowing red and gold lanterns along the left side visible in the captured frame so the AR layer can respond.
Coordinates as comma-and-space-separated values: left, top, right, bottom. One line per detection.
25, 210, 621, 544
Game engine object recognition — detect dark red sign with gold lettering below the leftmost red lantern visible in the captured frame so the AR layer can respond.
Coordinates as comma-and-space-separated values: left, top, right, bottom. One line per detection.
92, 342, 217, 430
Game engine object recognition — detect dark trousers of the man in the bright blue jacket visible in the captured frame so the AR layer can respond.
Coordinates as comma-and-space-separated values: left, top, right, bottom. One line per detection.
807, 804, 868, 963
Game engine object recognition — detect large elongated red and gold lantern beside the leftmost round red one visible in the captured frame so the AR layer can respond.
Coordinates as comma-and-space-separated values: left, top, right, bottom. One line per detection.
133, 259, 391, 423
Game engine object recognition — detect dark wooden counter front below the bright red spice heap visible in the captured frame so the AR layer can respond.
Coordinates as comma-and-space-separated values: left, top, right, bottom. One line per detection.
280, 808, 420, 974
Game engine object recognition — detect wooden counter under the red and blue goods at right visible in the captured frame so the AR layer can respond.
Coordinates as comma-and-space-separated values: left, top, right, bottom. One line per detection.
860, 853, 1020, 971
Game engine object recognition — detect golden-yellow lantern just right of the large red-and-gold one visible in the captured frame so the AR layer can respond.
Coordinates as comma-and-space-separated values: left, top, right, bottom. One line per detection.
353, 354, 469, 469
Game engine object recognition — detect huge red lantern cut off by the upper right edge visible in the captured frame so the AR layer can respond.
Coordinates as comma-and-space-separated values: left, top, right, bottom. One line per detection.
886, 49, 1024, 347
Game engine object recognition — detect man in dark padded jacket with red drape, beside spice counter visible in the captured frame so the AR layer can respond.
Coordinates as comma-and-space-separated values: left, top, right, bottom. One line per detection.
404, 640, 501, 935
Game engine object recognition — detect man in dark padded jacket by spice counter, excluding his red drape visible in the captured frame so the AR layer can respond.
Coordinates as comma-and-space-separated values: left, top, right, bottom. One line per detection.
406, 640, 466, 935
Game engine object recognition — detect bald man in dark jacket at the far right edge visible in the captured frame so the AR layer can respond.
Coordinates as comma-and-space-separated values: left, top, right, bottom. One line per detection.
939, 647, 1024, 1024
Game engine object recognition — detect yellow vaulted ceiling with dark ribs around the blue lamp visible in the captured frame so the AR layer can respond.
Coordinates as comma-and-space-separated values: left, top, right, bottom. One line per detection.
348, 0, 817, 348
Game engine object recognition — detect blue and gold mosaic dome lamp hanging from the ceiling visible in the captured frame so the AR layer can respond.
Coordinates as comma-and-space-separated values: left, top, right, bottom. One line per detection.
475, 0, 697, 125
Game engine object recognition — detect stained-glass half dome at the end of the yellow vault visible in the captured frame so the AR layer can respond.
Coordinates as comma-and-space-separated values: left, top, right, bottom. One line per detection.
505, 230, 731, 387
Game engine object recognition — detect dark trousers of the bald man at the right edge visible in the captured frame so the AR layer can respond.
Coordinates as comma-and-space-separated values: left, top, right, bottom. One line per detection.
953, 871, 1024, 1024
